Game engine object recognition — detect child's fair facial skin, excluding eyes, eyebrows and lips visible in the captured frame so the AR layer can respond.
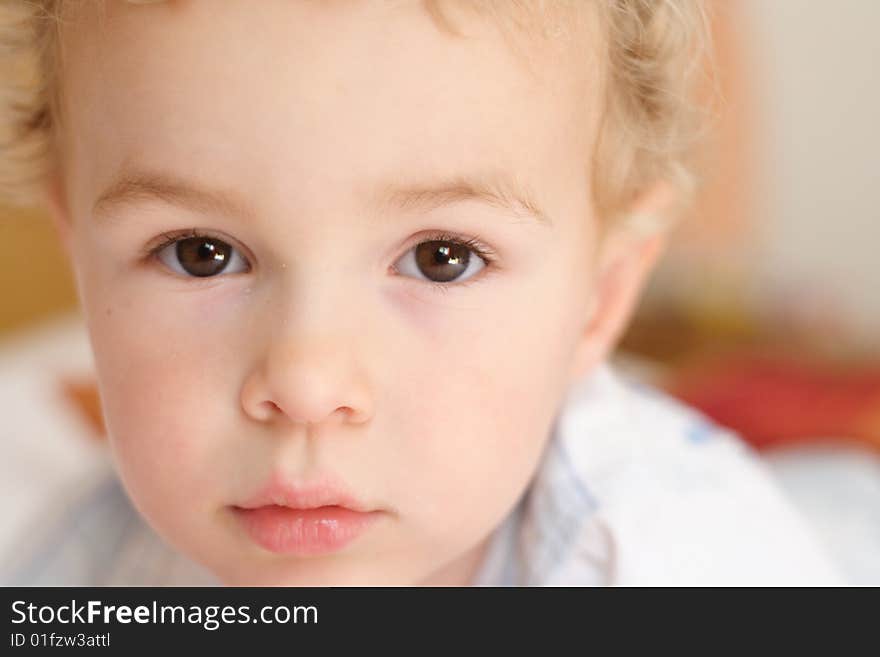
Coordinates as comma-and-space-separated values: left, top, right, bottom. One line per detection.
47, 0, 662, 585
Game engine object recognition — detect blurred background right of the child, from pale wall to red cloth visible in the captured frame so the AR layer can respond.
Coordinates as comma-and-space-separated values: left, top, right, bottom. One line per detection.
622, 0, 880, 448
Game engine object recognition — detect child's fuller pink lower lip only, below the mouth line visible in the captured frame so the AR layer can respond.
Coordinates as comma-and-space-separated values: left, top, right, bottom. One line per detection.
234, 506, 379, 556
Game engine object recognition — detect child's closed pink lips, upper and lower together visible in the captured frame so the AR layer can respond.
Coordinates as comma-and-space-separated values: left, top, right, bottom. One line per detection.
232, 477, 382, 556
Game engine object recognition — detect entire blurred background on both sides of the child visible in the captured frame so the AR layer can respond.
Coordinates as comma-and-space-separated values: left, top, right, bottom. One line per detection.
0, 0, 880, 584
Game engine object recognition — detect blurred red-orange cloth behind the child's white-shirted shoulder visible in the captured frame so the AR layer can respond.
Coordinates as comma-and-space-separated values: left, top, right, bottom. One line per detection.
665, 352, 880, 450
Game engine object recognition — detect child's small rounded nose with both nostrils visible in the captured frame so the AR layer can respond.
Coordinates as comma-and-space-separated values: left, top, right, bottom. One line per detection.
241, 332, 373, 426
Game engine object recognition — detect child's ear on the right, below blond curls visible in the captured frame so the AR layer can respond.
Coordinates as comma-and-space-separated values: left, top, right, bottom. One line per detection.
569, 183, 676, 383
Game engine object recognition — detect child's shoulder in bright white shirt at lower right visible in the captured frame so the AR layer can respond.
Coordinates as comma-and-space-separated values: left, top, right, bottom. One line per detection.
557, 365, 839, 584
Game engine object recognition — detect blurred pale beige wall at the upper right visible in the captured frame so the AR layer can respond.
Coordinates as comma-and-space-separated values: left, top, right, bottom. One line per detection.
740, 0, 880, 344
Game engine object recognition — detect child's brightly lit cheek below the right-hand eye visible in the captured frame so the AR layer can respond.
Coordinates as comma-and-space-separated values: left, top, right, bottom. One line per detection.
384, 270, 577, 540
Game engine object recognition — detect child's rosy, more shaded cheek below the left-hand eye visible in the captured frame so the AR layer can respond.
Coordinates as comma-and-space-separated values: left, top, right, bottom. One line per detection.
86, 278, 241, 528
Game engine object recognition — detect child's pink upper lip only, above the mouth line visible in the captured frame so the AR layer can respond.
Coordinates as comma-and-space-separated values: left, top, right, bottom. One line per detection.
235, 475, 372, 512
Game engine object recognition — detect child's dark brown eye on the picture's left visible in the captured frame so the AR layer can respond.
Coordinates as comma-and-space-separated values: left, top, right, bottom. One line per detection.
153, 233, 250, 278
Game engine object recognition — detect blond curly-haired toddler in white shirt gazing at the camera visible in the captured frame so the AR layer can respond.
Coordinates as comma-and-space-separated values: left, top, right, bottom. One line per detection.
2, 0, 836, 585
